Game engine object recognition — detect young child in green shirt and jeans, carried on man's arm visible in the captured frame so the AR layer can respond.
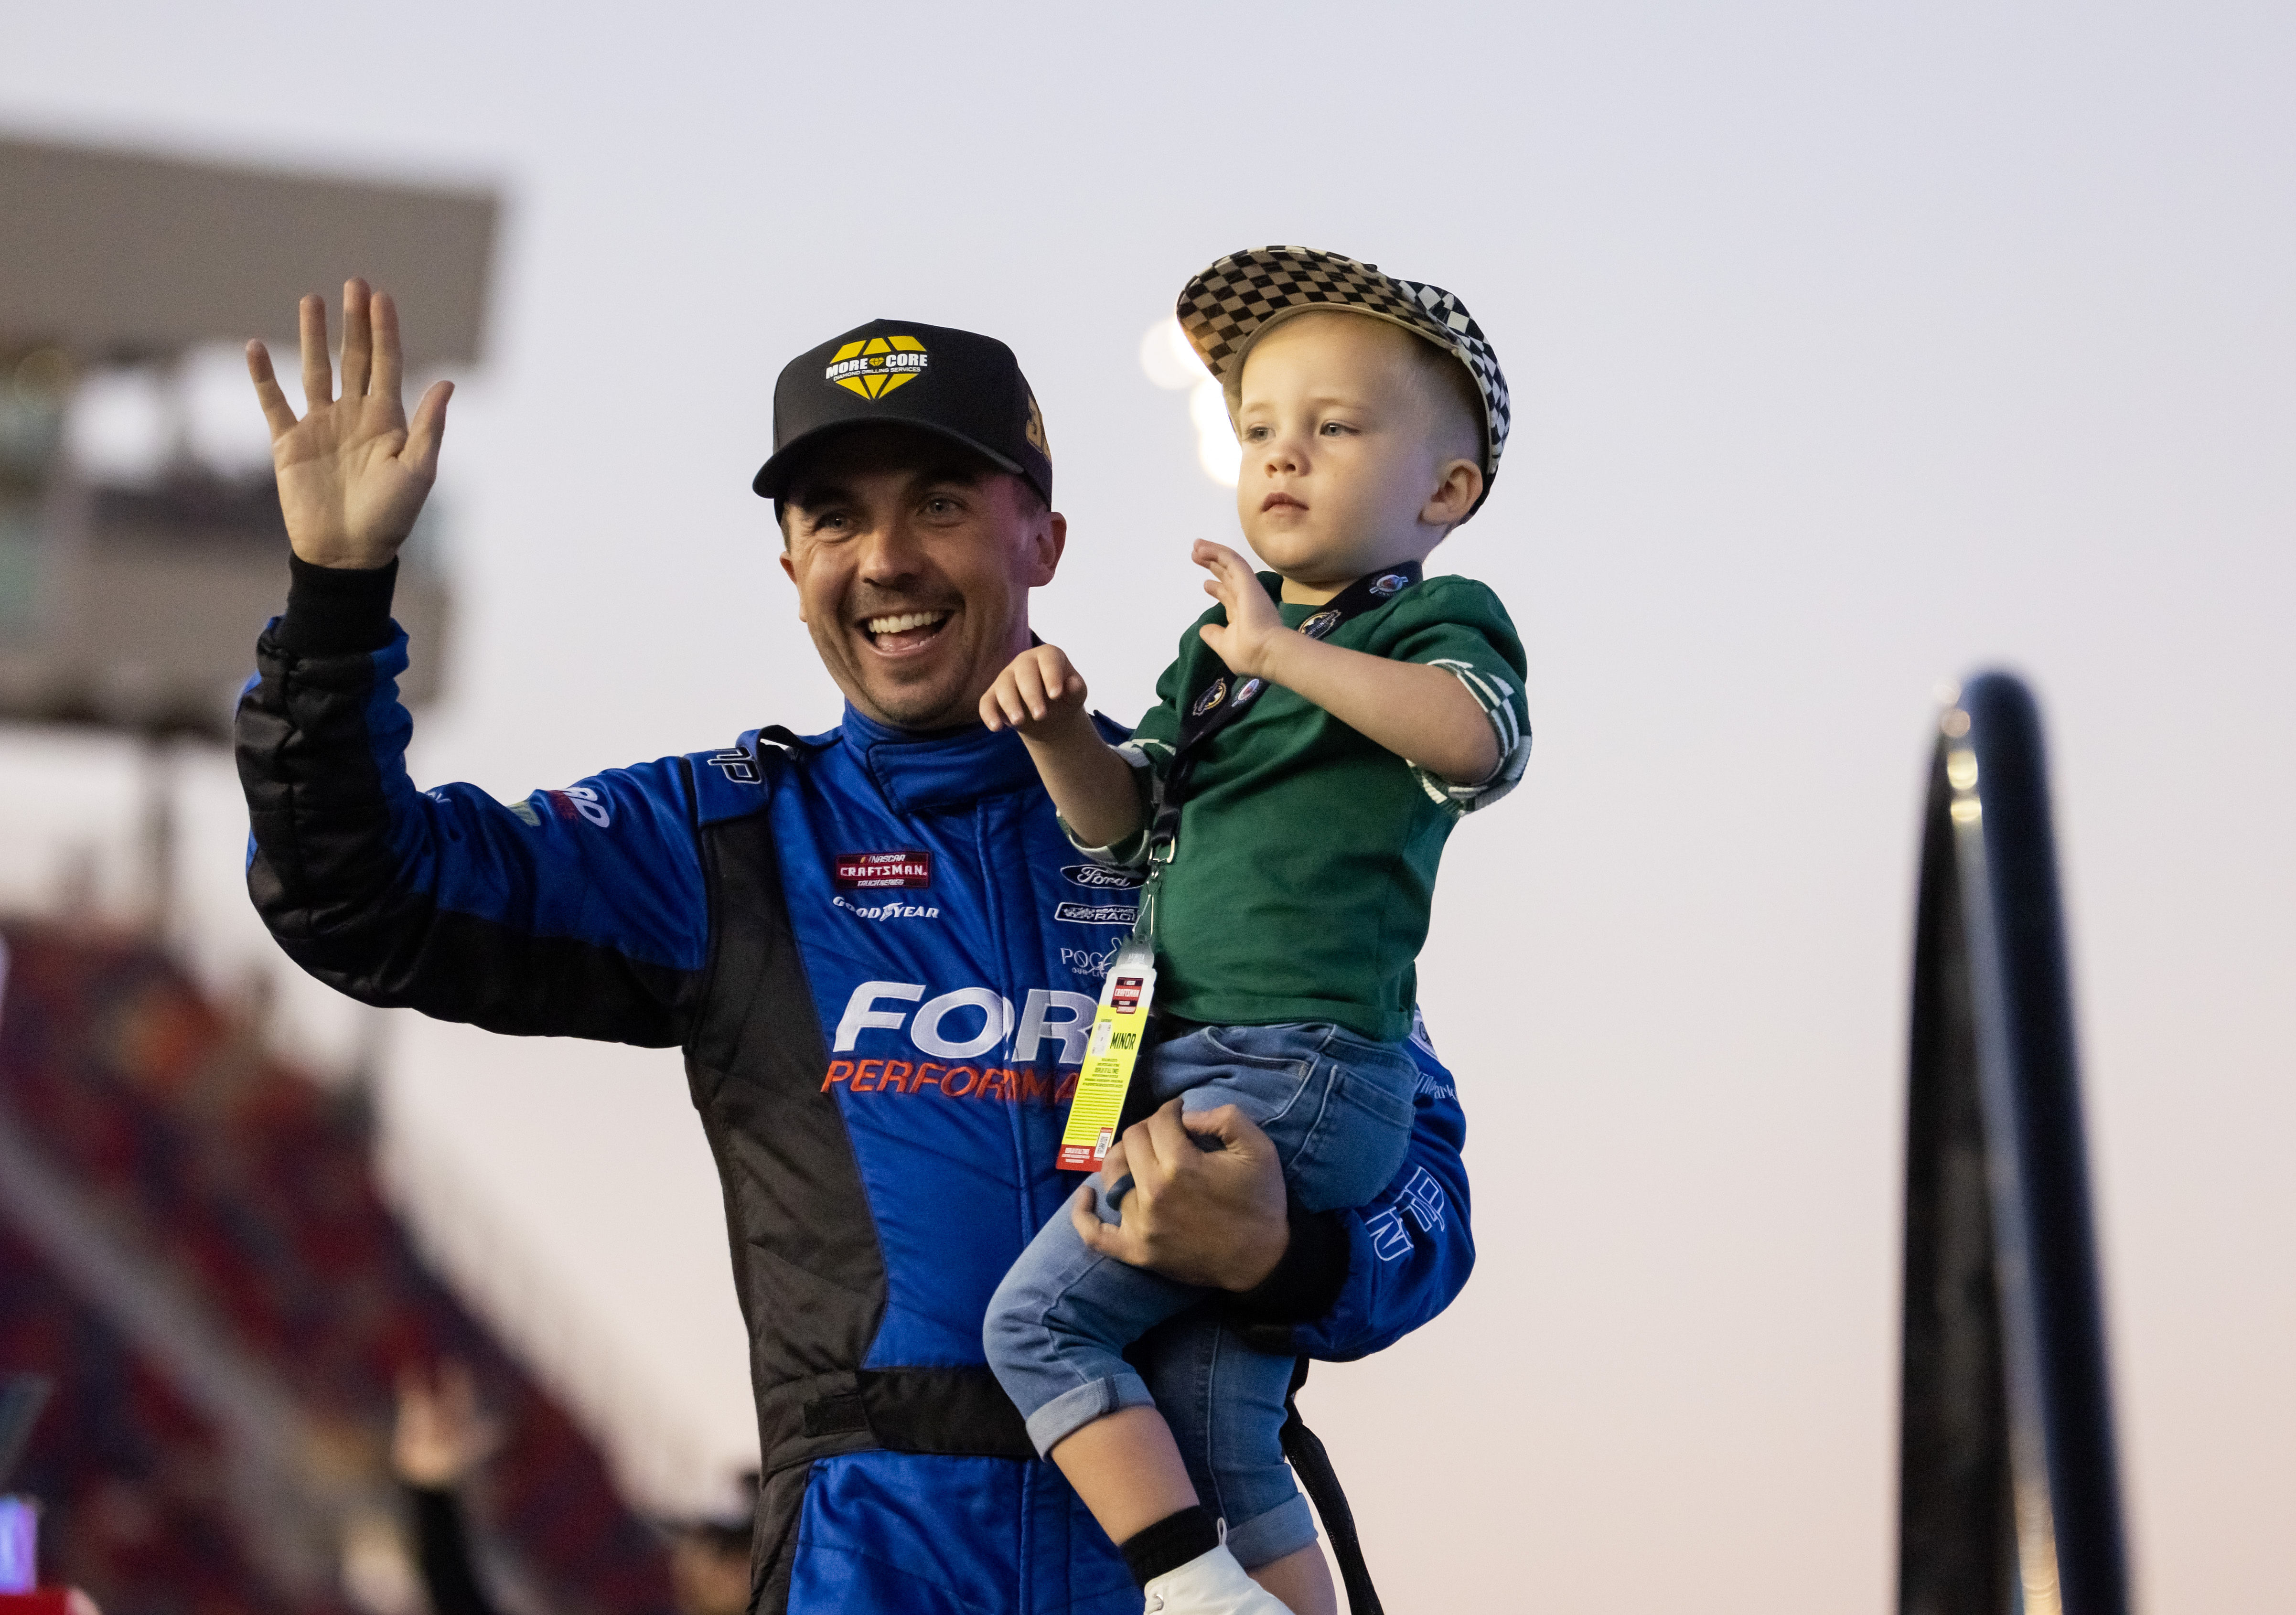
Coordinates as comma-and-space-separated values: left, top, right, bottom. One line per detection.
980, 248, 1529, 1615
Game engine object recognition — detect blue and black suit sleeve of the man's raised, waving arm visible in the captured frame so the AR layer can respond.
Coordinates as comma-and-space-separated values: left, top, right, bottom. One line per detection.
234, 560, 707, 1048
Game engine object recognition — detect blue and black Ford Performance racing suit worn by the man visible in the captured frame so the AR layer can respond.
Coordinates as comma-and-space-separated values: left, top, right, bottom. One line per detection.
236, 563, 1474, 1615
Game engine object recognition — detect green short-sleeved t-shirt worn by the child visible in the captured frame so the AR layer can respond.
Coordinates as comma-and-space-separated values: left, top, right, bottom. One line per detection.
1088, 572, 1532, 1041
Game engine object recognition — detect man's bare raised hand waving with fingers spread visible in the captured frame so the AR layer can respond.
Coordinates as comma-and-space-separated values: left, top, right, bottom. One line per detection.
248, 280, 455, 567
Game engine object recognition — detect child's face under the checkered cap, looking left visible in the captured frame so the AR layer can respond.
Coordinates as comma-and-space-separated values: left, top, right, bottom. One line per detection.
1235, 312, 1481, 588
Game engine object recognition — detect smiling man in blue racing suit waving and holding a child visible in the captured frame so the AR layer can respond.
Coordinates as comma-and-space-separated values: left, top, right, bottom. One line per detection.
236, 280, 1474, 1615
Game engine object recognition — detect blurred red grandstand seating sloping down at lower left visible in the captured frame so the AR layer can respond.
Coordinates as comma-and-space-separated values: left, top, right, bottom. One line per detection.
0, 923, 670, 1615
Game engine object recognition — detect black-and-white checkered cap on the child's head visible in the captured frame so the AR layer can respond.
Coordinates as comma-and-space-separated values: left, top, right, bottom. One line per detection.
1178, 246, 1509, 514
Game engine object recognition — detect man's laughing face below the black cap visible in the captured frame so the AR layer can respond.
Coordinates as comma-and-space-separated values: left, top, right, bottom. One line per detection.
781, 428, 1068, 730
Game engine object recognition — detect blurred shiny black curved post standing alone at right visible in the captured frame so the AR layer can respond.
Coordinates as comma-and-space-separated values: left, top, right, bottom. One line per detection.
1899, 673, 2128, 1615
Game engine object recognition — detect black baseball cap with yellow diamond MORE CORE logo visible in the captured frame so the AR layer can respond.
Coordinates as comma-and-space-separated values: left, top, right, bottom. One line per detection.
751, 320, 1051, 503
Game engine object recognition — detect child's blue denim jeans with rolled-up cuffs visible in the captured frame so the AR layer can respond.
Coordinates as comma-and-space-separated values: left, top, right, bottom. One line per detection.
983, 1022, 1419, 1569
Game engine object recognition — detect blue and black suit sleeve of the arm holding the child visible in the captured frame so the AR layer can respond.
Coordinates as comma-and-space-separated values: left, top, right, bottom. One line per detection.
1228, 1027, 1474, 1362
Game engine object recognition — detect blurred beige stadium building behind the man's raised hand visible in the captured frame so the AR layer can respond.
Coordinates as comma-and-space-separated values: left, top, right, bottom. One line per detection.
0, 140, 498, 930
